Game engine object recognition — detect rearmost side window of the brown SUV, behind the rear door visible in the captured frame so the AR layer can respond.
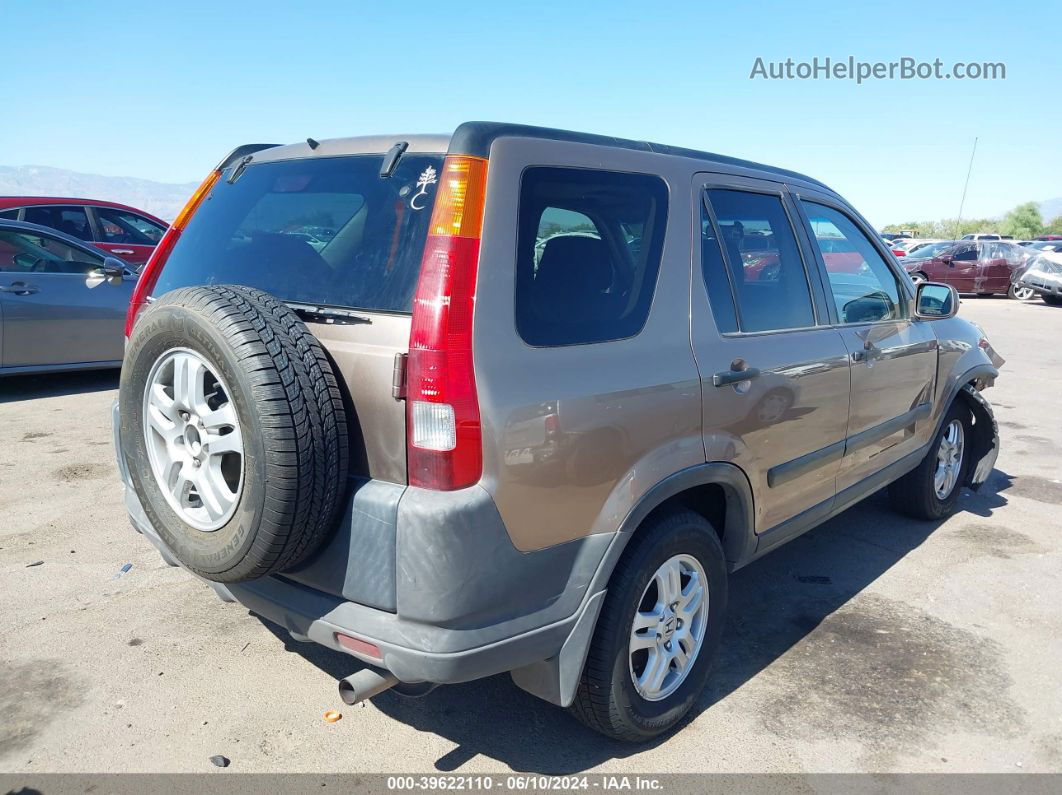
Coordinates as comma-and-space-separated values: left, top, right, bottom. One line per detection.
516, 168, 667, 346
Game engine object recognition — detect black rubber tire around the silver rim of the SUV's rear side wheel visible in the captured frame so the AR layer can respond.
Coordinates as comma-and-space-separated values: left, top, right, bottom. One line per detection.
569, 509, 726, 743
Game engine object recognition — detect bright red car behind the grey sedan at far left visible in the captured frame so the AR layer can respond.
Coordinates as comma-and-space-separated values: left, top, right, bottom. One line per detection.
0, 196, 168, 267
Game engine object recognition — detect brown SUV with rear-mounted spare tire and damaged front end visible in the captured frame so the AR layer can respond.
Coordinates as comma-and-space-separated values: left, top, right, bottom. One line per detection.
115, 122, 1001, 741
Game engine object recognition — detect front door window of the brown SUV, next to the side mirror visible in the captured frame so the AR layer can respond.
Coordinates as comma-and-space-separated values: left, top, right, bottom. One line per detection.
801, 201, 904, 323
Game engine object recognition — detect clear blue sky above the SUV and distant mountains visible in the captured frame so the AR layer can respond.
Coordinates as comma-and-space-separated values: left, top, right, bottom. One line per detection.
0, 0, 1062, 225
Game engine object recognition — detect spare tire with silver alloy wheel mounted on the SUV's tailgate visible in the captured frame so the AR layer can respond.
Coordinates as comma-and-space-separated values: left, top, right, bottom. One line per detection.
119, 286, 348, 583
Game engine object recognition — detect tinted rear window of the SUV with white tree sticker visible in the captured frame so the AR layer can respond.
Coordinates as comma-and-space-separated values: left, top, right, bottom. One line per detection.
154, 155, 443, 312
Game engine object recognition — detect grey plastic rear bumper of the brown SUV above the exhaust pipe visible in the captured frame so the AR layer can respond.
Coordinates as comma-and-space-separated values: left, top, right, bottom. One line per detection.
114, 402, 614, 684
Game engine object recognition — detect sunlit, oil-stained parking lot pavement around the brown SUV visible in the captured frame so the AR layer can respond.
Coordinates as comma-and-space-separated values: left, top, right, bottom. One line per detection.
0, 298, 1062, 774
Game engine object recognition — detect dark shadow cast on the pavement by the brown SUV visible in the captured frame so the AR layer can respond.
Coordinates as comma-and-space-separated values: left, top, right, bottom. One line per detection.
252, 470, 1013, 775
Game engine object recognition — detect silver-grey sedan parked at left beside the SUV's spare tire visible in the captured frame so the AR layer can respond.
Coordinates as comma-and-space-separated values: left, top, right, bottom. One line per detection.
0, 221, 137, 376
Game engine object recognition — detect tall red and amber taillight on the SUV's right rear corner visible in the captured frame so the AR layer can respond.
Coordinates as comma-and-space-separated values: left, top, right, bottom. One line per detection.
406, 156, 486, 490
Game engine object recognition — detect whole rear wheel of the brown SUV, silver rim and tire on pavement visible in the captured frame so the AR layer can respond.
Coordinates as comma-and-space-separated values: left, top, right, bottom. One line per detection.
571, 509, 726, 742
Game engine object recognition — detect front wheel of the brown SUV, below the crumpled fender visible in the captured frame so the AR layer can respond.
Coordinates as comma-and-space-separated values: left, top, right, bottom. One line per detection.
889, 402, 971, 519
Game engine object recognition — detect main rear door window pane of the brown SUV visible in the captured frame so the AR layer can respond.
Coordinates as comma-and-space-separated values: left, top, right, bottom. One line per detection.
707, 189, 815, 331
